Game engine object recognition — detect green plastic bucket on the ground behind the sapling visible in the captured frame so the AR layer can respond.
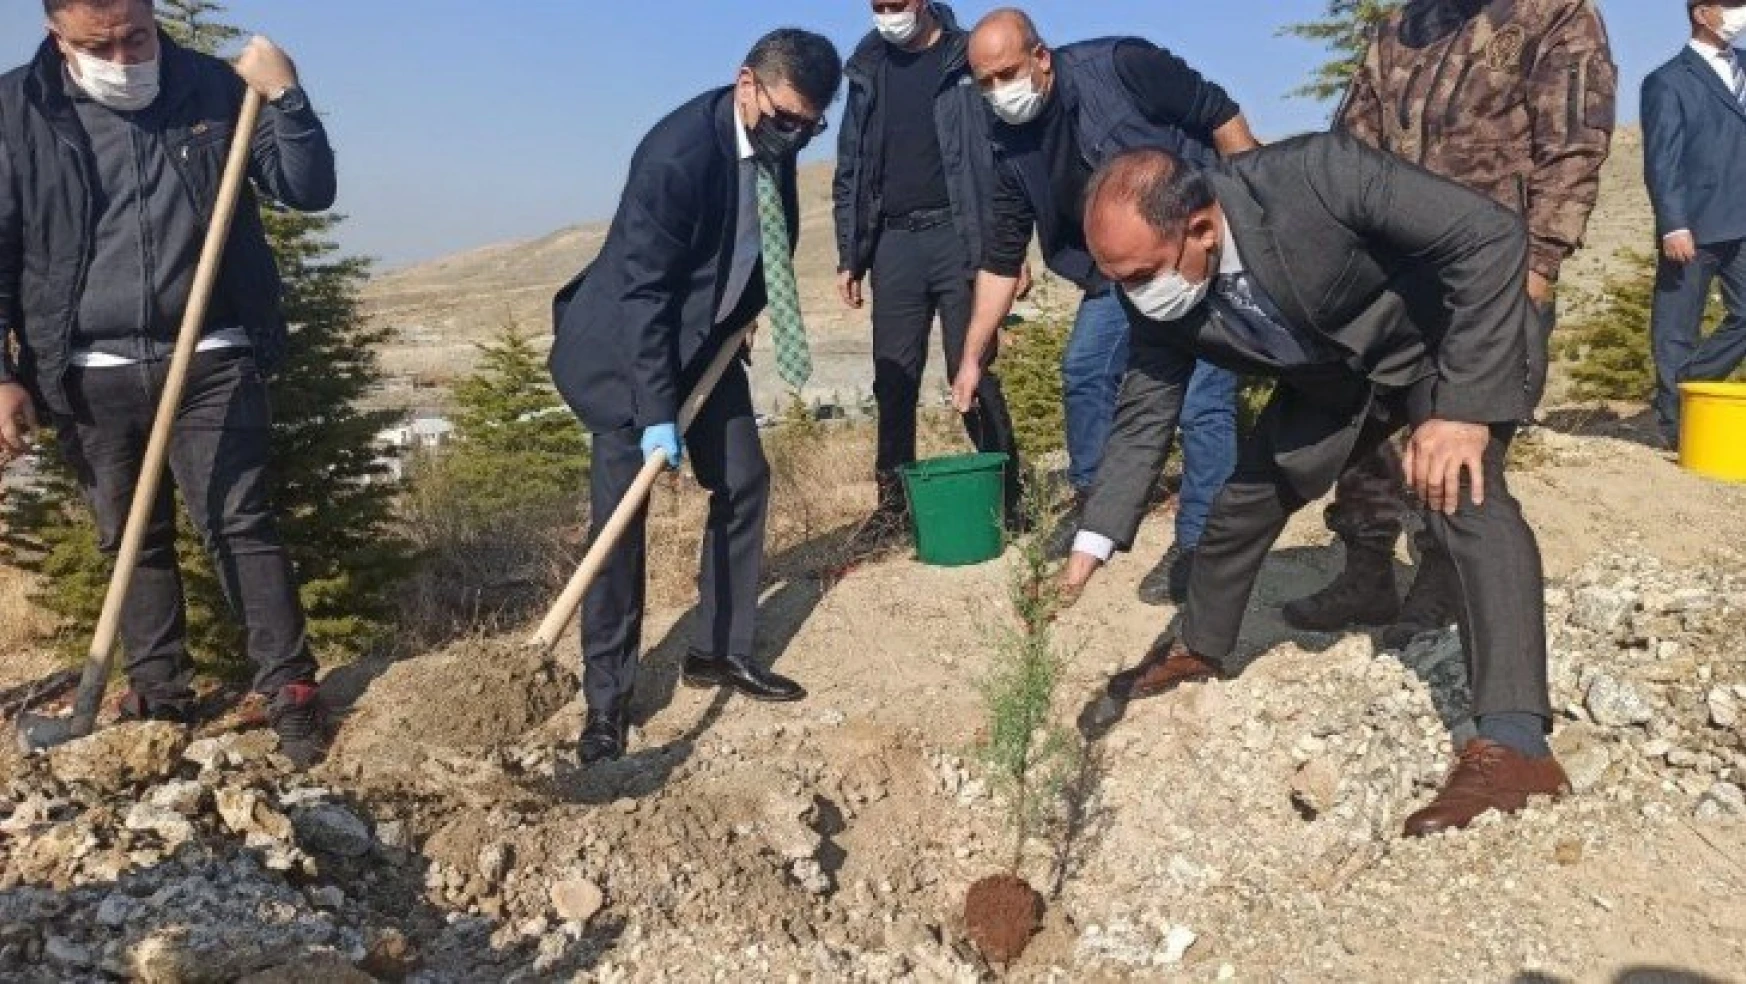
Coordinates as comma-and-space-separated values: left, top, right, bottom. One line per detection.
903, 454, 1007, 567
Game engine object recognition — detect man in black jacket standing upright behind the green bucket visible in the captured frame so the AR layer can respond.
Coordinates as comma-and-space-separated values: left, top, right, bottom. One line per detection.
833, 0, 1021, 541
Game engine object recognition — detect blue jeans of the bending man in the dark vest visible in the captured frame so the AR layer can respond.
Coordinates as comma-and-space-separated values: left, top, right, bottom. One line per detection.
1062, 290, 1236, 550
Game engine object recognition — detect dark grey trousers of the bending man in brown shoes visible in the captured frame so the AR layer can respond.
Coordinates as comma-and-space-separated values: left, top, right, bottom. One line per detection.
1182, 392, 1552, 717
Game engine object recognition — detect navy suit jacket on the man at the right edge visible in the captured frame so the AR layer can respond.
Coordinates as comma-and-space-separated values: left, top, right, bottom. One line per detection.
1643, 45, 1746, 243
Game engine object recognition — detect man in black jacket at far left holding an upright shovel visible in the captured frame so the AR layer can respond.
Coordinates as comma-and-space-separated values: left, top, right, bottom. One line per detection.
0, 0, 335, 764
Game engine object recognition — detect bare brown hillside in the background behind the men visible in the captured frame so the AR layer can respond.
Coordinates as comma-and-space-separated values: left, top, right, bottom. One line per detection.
365, 127, 1653, 407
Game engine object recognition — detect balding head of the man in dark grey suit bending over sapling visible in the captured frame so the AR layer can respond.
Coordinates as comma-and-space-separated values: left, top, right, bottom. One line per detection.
1086, 148, 1224, 296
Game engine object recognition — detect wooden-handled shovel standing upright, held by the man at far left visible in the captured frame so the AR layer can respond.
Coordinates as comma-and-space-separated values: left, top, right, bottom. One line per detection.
17, 89, 260, 754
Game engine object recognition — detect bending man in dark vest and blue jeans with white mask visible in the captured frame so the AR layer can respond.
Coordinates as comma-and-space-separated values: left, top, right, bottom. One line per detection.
953, 9, 1255, 600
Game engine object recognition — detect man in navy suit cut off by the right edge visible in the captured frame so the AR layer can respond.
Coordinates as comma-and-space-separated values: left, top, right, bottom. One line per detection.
1643, 0, 1746, 447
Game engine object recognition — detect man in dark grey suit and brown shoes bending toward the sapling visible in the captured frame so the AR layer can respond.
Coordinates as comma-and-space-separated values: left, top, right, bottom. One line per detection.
1063, 134, 1566, 836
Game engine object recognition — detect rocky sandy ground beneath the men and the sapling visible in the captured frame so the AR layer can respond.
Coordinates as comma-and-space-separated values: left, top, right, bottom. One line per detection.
0, 427, 1746, 982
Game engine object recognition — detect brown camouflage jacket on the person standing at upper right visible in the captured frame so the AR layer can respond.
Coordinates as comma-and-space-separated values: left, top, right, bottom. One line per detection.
1336, 0, 1619, 281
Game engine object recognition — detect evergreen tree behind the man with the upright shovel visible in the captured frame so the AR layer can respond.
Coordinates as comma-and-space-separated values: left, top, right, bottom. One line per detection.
5, 0, 410, 670
